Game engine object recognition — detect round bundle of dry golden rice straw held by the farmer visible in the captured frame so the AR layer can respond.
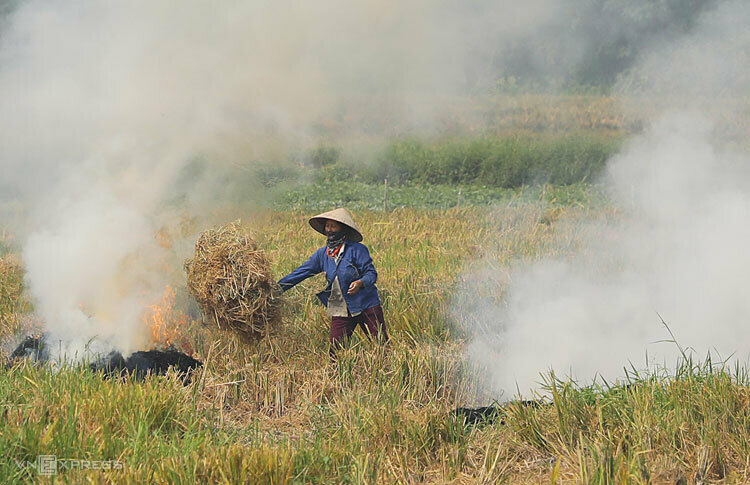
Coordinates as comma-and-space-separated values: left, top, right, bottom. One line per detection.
185, 220, 281, 337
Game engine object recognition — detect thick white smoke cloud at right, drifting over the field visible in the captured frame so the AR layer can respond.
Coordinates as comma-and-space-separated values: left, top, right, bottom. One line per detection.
455, 1, 750, 398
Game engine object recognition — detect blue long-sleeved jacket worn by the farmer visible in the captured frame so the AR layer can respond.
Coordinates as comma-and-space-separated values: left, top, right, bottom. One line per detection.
279, 241, 380, 313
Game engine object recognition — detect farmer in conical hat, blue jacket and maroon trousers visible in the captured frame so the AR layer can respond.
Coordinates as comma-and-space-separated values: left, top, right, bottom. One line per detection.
279, 208, 388, 357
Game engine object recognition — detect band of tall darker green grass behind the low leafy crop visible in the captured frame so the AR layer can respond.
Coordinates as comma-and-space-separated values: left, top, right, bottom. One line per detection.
253, 133, 622, 194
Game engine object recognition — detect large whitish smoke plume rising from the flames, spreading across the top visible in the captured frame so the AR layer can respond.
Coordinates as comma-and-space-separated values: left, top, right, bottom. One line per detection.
0, 0, 588, 357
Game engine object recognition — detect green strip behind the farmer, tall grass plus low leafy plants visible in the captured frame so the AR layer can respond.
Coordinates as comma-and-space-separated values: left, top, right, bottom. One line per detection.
260, 130, 621, 211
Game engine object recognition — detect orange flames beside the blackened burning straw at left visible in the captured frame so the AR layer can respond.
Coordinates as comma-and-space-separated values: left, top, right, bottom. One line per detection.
144, 285, 193, 354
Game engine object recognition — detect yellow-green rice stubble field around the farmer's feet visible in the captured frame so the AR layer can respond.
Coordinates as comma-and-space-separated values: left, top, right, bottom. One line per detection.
0, 204, 750, 483
